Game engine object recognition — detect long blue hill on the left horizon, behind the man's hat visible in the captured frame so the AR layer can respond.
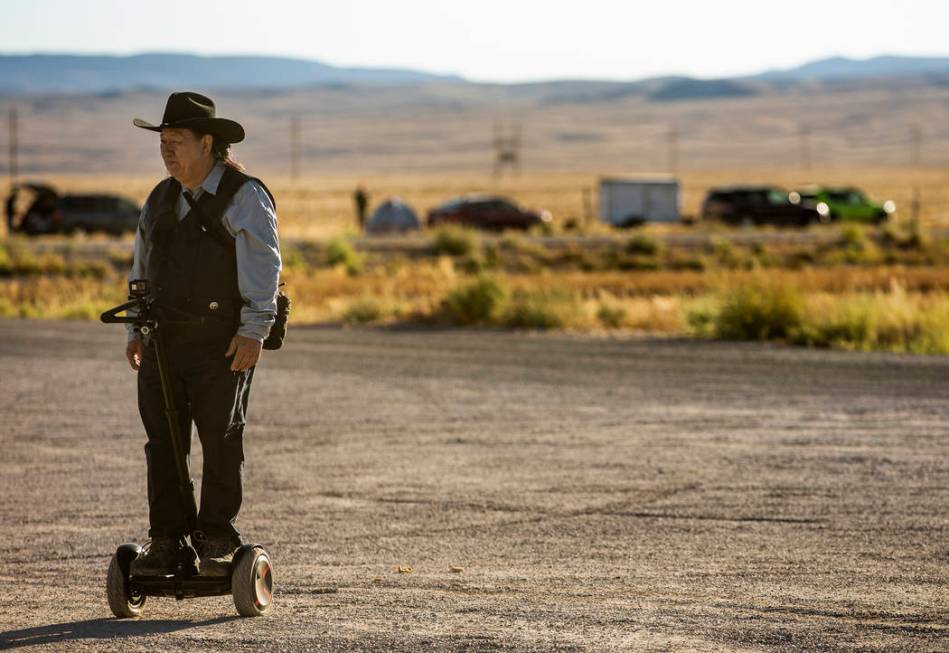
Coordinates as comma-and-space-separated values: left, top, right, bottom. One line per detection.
0, 53, 463, 94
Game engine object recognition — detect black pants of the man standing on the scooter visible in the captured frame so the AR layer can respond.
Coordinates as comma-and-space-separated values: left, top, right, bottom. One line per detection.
138, 339, 254, 544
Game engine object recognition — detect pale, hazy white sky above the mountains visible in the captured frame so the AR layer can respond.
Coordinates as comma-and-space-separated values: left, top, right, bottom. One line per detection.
0, 0, 949, 81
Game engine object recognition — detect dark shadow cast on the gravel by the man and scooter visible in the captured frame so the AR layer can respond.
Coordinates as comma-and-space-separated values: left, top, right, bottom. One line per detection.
0, 615, 240, 649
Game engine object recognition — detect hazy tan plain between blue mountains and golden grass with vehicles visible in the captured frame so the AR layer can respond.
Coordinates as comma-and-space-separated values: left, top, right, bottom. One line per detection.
0, 80, 949, 177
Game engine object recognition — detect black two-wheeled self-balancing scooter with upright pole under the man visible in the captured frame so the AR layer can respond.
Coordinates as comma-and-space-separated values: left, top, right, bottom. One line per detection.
101, 279, 273, 618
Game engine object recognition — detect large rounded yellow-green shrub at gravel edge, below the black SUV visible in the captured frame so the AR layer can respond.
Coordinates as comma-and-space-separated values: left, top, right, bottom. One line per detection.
714, 283, 804, 340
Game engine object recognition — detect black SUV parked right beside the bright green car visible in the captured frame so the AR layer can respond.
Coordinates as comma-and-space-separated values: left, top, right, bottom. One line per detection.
702, 186, 830, 227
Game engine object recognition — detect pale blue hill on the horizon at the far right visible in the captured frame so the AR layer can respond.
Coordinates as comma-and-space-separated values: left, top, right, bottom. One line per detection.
752, 56, 949, 81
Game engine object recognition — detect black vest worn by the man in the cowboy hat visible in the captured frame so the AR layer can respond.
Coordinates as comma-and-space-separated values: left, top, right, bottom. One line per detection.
143, 167, 269, 343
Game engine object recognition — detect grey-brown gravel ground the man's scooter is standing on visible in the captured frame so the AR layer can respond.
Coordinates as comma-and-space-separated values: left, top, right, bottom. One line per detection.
0, 321, 949, 651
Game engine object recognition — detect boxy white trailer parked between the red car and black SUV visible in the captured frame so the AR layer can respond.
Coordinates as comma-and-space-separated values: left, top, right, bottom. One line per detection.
599, 177, 681, 227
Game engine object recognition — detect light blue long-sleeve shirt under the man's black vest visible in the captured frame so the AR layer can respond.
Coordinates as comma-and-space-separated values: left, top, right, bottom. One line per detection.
129, 162, 281, 342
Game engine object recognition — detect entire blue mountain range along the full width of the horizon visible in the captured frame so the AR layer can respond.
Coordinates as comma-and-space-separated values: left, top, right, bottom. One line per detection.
0, 52, 949, 94
